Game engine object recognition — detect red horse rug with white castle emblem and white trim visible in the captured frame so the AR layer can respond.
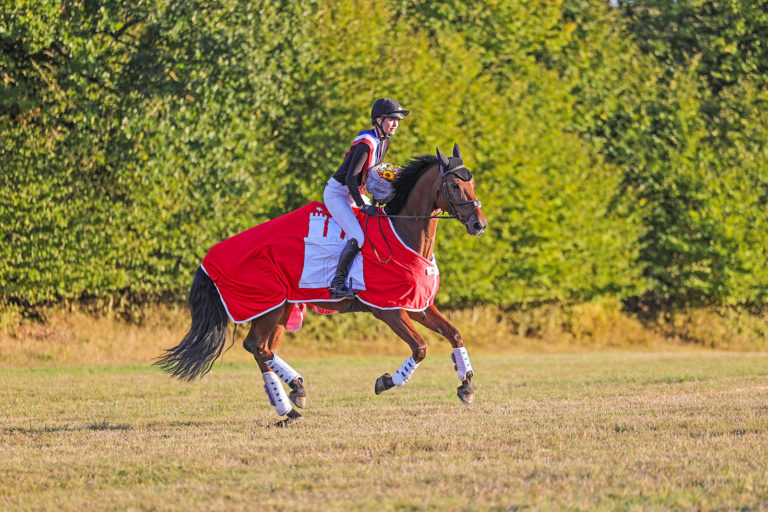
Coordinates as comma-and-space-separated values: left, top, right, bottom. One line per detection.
202, 202, 440, 329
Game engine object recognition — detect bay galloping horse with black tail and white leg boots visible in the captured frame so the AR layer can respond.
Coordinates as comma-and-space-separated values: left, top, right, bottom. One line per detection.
155, 144, 488, 426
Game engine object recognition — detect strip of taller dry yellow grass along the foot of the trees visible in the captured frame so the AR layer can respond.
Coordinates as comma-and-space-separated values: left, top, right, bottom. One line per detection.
0, 300, 768, 368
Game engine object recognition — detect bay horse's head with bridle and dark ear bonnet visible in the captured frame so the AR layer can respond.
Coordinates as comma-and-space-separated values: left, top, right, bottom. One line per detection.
437, 144, 488, 236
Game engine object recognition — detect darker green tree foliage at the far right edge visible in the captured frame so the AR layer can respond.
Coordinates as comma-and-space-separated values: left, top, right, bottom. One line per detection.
609, 0, 768, 304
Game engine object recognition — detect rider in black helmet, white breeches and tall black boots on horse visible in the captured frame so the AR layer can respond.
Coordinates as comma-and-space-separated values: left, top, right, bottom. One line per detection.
323, 98, 410, 299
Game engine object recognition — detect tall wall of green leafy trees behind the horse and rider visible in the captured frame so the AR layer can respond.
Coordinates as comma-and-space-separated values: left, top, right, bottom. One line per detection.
0, 0, 768, 307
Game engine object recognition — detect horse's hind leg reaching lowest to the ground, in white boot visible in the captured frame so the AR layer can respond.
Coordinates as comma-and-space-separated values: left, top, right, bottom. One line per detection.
243, 304, 301, 420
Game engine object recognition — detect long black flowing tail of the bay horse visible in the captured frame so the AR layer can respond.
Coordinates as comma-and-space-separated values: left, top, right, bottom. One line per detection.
155, 267, 229, 381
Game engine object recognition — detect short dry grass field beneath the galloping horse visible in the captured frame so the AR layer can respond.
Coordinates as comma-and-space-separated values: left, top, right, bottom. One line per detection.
0, 348, 768, 510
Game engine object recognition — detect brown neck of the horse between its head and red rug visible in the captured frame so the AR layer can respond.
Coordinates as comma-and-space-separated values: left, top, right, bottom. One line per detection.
392, 166, 440, 259
